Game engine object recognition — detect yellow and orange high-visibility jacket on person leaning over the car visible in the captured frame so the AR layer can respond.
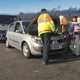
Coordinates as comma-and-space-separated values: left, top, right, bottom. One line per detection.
38, 13, 55, 36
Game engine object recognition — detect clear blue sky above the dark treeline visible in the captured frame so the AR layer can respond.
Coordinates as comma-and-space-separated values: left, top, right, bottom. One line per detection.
0, 0, 80, 14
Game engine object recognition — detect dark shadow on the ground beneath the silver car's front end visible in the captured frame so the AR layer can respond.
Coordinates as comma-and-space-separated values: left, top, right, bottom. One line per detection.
32, 53, 80, 64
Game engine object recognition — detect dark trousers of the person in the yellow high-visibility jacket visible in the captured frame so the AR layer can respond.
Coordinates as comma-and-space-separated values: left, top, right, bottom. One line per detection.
41, 33, 50, 62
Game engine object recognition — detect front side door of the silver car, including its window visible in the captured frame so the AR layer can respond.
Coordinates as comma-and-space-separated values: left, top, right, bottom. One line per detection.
14, 22, 23, 49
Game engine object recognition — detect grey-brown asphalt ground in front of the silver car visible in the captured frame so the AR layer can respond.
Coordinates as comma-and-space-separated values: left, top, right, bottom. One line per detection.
0, 43, 80, 80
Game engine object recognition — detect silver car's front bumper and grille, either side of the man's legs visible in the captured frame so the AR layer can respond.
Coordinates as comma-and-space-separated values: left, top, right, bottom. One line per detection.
31, 33, 68, 54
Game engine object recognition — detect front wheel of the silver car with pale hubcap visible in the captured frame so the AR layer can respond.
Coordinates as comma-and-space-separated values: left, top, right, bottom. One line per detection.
22, 43, 31, 58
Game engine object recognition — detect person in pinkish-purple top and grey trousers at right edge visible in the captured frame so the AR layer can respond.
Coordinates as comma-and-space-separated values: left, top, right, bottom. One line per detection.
71, 16, 80, 56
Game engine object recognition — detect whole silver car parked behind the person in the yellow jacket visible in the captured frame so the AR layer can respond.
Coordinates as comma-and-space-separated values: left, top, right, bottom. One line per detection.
6, 21, 67, 58
